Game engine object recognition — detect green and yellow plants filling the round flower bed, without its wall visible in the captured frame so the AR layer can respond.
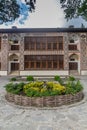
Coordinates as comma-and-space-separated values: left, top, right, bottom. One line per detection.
5, 77, 83, 97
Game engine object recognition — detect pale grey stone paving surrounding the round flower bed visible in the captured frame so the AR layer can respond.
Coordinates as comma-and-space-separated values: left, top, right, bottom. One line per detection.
0, 77, 87, 130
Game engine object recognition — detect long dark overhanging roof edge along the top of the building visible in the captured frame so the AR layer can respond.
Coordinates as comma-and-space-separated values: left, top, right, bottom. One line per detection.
0, 28, 87, 33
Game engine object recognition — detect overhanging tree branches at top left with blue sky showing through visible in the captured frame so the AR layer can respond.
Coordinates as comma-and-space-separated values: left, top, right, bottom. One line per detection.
0, 0, 36, 24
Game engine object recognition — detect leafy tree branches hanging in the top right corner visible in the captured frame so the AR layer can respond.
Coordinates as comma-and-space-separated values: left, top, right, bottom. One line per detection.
60, 0, 87, 20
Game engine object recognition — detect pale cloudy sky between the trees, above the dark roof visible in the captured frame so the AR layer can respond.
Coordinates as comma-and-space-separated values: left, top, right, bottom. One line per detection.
0, 0, 87, 28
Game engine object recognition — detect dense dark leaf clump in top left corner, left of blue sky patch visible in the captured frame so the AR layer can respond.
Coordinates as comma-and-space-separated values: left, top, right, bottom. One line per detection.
0, 0, 20, 24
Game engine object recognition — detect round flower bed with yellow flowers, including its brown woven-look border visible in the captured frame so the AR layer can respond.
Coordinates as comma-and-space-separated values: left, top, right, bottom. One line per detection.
5, 77, 83, 107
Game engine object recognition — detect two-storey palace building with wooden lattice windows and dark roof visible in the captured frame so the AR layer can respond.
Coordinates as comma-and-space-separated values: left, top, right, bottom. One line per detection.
0, 27, 87, 75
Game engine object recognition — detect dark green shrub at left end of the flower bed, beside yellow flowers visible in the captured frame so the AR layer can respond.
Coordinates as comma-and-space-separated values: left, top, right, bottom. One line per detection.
5, 83, 25, 94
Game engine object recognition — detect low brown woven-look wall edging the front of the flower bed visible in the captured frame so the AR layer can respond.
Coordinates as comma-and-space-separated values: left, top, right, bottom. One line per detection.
5, 91, 84, 107
